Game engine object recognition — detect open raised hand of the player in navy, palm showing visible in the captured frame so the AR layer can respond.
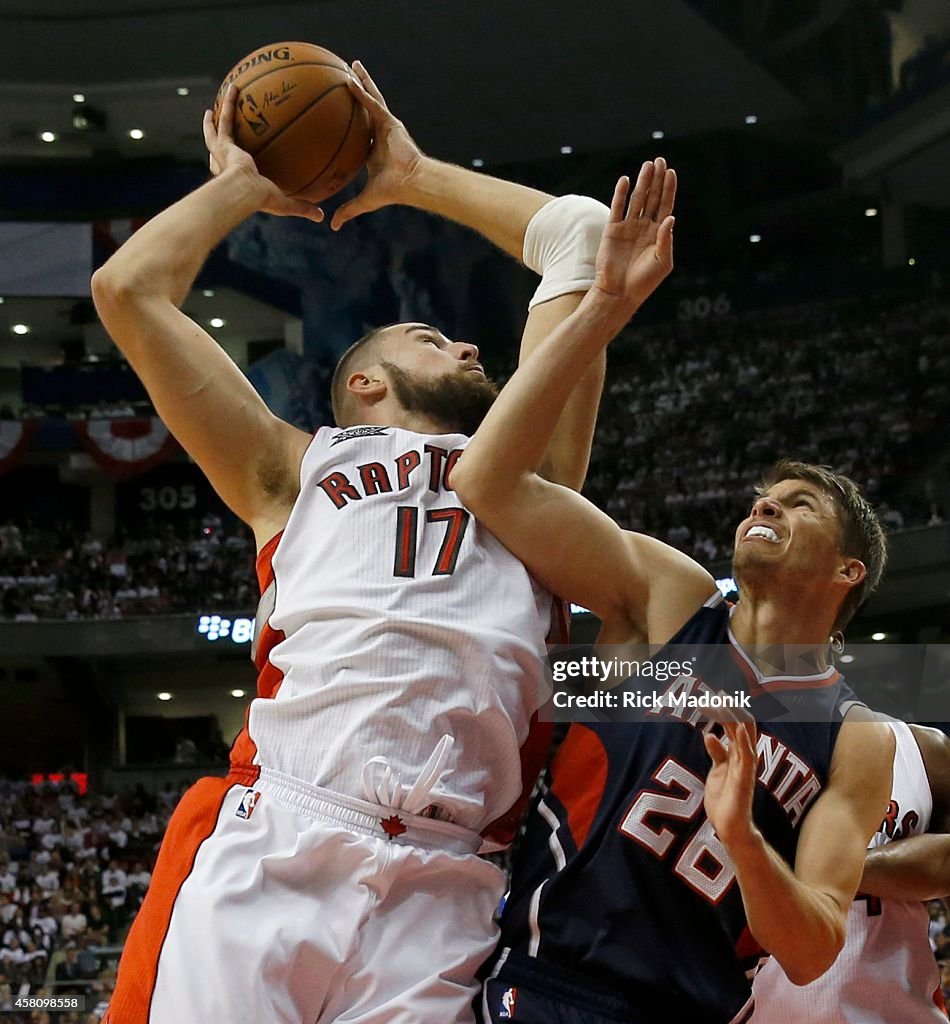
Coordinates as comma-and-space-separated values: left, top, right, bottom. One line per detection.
592, 157, 677, 316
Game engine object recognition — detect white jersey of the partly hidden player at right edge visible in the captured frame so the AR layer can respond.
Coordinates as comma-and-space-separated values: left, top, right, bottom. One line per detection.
752, 722, 947, 1024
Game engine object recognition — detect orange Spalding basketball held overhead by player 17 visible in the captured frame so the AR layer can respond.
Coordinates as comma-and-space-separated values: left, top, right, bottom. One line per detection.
214, 43, 373, 203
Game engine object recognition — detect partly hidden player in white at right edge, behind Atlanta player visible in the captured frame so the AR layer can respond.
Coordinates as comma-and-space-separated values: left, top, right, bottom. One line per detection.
752, 722, 950, 1024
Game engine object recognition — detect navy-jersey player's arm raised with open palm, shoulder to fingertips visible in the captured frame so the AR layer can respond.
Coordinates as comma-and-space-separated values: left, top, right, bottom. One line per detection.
451, 172, 713, 626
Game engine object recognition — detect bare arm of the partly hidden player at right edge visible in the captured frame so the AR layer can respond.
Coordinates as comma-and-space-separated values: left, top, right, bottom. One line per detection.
859, 725, 950, 900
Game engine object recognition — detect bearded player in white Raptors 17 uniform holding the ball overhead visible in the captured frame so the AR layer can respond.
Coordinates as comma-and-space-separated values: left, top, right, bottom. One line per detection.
93, 66, 676, 1024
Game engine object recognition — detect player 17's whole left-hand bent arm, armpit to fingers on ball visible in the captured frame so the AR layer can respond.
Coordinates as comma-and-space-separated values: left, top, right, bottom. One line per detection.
92, 87, 322, 543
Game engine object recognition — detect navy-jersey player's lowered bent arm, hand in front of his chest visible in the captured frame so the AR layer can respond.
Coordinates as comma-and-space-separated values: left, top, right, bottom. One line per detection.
705, 712, 895, 985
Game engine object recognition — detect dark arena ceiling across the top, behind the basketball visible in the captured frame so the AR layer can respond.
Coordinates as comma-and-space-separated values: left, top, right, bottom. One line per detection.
0, 0, 804, 165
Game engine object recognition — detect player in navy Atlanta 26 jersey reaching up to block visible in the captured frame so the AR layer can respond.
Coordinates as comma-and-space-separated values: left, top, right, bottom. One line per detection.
451, 172, 894, 1024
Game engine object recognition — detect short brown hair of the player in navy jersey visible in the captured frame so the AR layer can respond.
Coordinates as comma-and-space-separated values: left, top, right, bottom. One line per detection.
755, 459, 888, 630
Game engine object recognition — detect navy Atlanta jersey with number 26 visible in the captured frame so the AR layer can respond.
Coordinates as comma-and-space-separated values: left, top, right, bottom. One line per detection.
492, 594, 856, 1024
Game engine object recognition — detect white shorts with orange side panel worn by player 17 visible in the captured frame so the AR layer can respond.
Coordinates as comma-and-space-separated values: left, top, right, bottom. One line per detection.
103, 769, 505, 1024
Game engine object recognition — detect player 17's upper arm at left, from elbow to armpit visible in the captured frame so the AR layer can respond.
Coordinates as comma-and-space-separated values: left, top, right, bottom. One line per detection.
87, 282, 310, 542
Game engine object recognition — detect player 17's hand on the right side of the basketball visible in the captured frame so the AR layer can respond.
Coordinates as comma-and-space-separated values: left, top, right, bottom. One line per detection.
330, 60, 422, 231
